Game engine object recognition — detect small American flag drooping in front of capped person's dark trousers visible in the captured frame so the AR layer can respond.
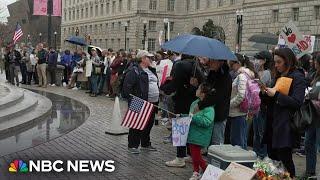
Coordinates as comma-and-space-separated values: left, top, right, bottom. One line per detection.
121, 96, 154, 130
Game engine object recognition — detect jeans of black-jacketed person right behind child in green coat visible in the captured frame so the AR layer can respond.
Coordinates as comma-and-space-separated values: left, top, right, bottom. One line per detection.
211, 120, 227, 145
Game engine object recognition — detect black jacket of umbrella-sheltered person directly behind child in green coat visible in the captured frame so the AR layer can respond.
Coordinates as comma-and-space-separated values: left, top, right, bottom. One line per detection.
198, 64, 232, 122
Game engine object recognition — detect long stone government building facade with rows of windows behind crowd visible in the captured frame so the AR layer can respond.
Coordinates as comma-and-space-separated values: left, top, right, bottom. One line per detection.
61, 0, 320, 53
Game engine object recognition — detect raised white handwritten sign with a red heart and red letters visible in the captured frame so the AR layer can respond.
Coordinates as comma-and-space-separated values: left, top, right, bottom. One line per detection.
280, 21, 311, 58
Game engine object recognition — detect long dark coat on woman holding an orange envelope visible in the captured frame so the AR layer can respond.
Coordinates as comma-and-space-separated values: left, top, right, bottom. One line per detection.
260, 70, 307, 148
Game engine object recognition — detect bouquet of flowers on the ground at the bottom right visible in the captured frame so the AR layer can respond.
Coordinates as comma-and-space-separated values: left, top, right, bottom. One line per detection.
253, 158, 291, 180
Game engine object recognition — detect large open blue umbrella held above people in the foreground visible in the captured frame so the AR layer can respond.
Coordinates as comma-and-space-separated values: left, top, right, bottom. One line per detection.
161, 34, 237, 60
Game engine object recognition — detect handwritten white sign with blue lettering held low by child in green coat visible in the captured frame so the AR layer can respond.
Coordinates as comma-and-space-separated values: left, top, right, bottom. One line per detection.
172, 117, 191, 146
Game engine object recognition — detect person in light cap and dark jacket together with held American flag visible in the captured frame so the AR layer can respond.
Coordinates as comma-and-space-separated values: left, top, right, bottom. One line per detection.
122, 50, 159, 154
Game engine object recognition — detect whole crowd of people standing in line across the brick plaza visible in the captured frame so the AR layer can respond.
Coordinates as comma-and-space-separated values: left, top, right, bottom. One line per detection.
0, 43, 320, 179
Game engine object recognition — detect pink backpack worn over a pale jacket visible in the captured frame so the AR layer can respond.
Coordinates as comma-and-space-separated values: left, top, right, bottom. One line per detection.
240, 73, 261, 115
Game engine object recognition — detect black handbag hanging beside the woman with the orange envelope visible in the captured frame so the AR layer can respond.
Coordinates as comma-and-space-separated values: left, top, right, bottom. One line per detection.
290, 99, 317, 132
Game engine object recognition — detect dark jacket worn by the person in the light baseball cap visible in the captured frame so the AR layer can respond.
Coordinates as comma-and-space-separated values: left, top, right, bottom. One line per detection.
122, 64, 157, 104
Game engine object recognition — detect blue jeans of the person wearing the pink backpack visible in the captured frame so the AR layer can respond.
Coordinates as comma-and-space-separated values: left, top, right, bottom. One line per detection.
230, 116, 247, 149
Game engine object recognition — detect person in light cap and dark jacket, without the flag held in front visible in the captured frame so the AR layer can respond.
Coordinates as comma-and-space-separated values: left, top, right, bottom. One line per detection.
123, 50, 159, 154
